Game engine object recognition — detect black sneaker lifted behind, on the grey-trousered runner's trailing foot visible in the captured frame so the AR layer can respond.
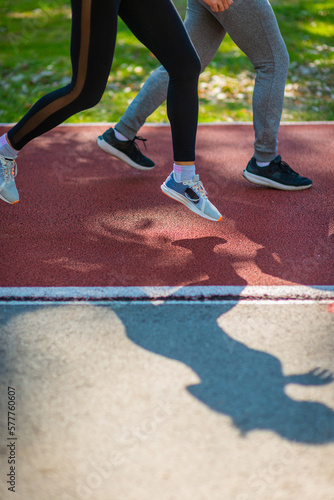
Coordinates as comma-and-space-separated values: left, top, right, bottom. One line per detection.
97, 128, 155, 170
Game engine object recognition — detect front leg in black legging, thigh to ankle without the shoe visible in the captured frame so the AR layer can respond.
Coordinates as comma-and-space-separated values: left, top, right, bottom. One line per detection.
119, 0, 200, 161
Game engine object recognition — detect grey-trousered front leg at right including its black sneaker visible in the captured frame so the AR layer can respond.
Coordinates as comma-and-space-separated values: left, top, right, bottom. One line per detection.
198, 0, 312, 190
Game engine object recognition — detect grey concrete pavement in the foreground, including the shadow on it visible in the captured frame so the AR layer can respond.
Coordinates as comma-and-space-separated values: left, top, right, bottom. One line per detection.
0, 300, 334, 500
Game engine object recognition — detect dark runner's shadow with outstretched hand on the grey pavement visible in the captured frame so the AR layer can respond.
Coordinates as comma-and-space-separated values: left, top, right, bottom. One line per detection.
116, 304, 334, 444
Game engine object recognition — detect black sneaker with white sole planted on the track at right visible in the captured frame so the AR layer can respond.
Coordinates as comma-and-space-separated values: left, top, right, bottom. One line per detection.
242, 156, 312, 191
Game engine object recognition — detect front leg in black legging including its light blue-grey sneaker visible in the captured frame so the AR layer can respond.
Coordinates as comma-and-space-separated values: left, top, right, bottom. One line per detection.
115, 0, 221, 221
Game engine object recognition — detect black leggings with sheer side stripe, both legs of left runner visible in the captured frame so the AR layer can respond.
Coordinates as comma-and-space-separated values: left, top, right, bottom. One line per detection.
8, 0, 200, 161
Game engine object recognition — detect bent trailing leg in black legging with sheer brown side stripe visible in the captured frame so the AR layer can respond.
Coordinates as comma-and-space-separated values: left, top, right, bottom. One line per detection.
7, 0, 120, 150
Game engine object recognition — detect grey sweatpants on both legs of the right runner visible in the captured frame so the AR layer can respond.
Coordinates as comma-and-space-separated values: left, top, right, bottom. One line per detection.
116, 0, 289, 162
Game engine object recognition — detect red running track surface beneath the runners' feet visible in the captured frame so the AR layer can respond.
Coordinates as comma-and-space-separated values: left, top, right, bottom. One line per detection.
0, 124, 334, 286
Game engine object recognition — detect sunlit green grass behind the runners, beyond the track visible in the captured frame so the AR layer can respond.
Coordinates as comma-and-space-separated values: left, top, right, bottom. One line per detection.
0, 0, 334, 122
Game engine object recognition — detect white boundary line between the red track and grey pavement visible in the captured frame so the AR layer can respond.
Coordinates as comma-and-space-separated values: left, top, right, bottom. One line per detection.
0, 285, 334, 303
